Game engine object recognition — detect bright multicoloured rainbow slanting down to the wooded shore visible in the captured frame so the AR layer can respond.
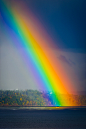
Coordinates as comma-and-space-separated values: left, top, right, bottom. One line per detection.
0, 0, 77, 106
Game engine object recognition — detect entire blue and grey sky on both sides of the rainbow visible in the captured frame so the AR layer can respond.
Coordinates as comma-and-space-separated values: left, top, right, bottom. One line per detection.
0, 0, 86, 92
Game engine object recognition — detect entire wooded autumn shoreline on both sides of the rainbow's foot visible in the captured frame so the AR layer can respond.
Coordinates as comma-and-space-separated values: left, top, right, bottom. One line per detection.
0, 90, 86, 106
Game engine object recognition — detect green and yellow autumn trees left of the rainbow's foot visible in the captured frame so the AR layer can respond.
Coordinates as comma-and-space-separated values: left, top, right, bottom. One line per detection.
0, 90, 51, 106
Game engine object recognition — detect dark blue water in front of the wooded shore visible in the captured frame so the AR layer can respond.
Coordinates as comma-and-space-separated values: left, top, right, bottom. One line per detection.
0, 108, 86, 129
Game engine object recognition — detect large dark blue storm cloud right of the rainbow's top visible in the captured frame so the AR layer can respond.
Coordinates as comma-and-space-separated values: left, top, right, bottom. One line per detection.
26, 0, 86, 52
